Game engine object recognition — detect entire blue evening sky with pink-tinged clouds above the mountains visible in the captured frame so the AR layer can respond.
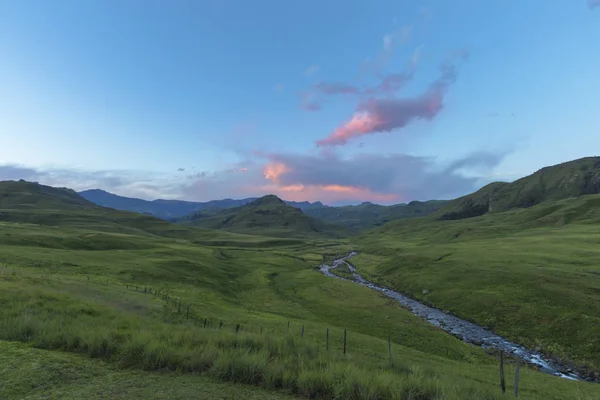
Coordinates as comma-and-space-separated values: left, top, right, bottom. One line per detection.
0, 0, 600, 205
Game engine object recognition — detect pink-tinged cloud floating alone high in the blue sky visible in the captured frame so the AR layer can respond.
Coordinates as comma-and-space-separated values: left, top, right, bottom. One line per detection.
316, 50, 468, 146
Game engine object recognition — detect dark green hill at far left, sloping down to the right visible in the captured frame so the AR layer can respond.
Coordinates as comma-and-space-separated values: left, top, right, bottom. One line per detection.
0, 180, 298, 248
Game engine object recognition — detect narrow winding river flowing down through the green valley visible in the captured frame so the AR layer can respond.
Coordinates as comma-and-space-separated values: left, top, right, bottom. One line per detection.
319, 252, 582, 380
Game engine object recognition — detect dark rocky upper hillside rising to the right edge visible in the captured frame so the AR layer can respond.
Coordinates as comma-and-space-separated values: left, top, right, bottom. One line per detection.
435, 157, 600, 220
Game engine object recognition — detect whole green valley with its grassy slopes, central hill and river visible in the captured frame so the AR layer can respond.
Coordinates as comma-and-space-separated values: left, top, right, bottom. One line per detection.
0, 159, 600, 400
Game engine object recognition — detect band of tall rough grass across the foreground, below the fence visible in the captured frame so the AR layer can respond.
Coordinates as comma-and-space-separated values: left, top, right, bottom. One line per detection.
0, 282, 495, 400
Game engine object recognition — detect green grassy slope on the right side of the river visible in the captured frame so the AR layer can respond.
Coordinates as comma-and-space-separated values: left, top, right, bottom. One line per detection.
352, 195, 600, 375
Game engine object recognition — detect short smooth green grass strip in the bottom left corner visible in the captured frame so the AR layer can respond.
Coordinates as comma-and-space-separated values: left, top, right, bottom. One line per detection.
0, 341, 292, 400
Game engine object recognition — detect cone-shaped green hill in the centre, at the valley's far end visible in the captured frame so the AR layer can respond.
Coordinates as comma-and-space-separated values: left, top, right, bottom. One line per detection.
180, 195, 350, 237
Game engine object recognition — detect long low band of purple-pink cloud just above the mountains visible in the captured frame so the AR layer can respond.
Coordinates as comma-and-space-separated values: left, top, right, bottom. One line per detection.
0, 145, 506, 204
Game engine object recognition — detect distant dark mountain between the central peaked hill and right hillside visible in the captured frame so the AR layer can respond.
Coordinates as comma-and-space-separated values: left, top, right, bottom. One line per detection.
304, 200, 448, 229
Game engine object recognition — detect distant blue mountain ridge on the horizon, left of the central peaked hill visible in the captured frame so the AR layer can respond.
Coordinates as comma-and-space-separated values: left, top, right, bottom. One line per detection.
79, 189, 324, 220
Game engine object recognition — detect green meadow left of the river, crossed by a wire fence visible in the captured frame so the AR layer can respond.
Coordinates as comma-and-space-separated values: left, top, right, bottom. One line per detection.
0, 217, 598, 400
